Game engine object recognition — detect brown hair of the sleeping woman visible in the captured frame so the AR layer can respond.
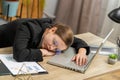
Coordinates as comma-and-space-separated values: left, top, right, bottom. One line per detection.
52, 23, 74, 47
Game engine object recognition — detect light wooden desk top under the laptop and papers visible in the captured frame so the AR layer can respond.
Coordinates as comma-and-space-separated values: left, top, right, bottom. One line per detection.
0, 33, 120, 80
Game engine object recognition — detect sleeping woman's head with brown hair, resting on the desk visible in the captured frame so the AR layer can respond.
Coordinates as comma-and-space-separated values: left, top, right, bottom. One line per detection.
42, 24, 73, 51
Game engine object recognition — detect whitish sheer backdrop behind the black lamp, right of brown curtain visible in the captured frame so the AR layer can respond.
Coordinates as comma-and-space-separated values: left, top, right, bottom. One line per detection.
100, 0, 120, 43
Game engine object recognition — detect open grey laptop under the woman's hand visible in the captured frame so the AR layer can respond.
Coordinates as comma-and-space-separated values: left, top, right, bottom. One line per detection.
47, 29, 113, 73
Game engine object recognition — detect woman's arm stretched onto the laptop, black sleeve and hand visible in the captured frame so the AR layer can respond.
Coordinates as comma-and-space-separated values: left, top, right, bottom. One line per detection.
72, 37, 90, 65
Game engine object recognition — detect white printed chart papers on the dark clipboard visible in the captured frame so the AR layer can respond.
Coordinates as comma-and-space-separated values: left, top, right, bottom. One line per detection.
0, 54, 47, 75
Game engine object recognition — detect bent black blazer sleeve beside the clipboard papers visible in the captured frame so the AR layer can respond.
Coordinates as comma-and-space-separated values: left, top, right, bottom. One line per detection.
13, 24, 43, 62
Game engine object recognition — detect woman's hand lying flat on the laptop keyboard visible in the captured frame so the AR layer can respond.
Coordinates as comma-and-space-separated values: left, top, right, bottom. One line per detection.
72, 48, 87, 66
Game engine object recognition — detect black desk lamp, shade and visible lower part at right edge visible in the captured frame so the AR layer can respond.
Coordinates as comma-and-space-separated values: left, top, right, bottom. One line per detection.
108, 7, 120, 60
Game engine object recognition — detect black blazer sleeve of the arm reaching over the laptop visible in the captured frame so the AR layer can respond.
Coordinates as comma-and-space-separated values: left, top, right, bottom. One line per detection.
71, 37, 90, 55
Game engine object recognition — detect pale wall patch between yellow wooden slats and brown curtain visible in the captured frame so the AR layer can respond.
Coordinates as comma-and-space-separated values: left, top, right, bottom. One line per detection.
44, 0, 58, 16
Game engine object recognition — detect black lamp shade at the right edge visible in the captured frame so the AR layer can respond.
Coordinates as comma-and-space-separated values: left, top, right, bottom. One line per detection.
108, 7, 120, 23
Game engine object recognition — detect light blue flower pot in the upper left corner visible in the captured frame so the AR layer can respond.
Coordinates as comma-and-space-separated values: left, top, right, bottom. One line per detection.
2, 0, 19, 17
